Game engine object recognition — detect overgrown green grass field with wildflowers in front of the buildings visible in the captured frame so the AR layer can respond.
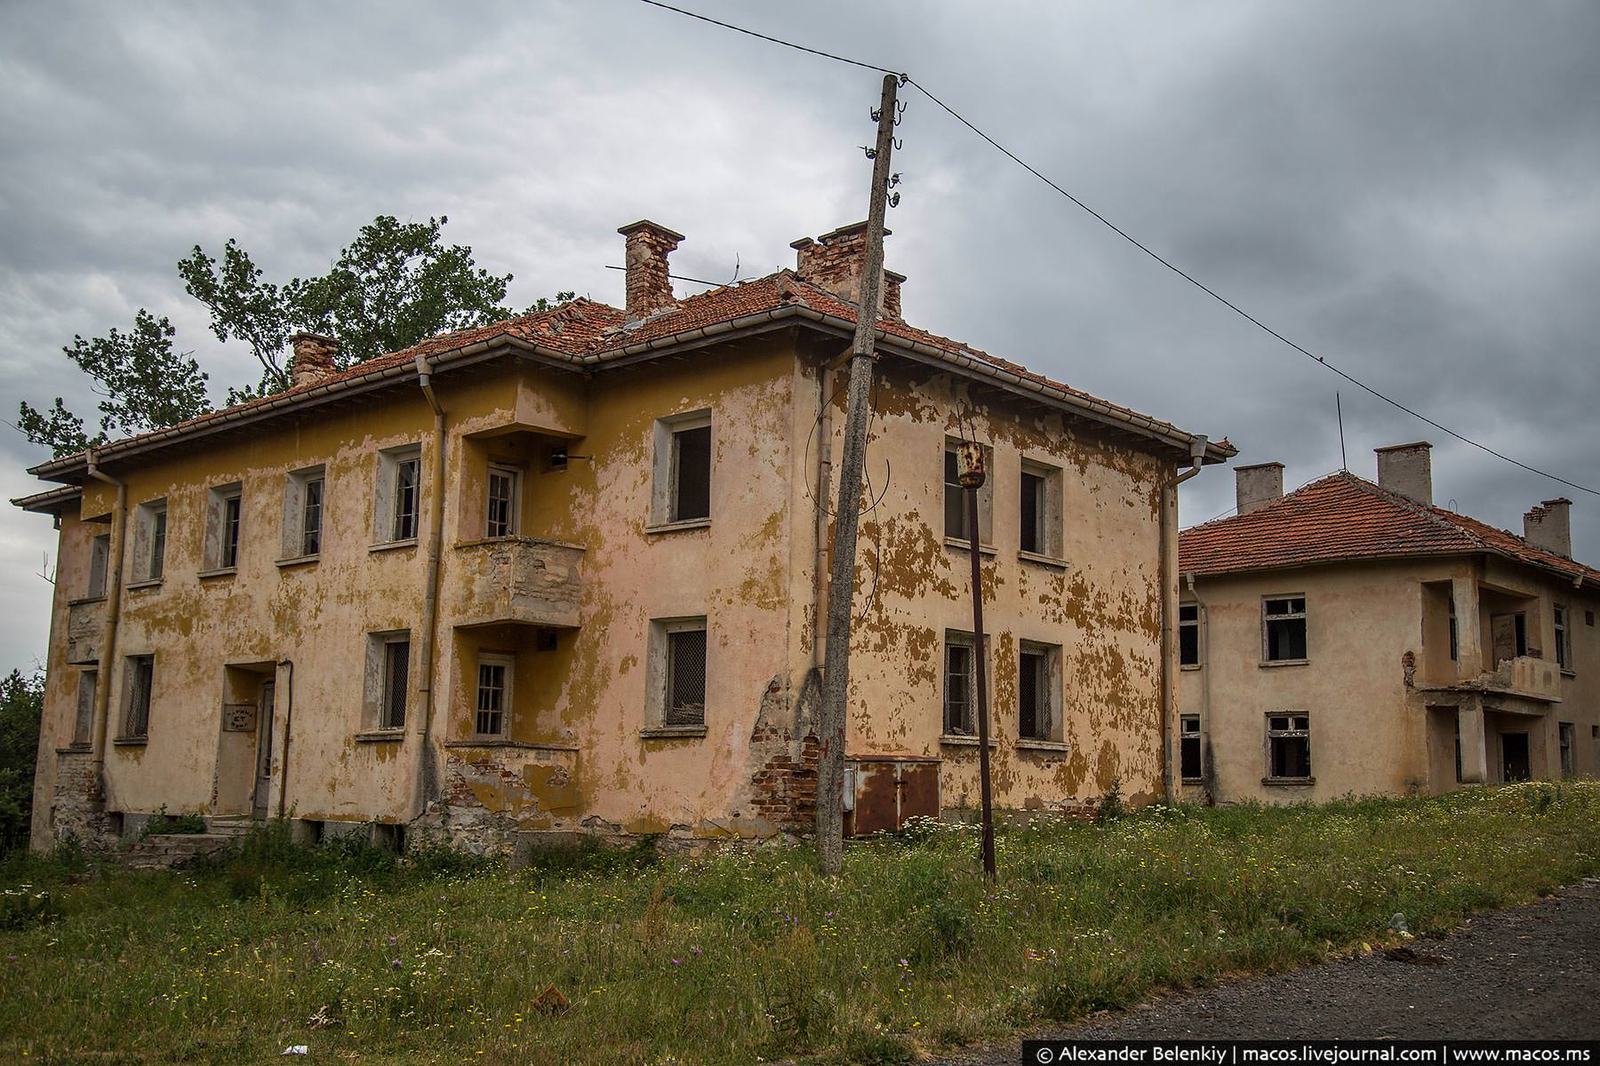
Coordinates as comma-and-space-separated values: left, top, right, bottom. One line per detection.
0, 783, 1600, 1064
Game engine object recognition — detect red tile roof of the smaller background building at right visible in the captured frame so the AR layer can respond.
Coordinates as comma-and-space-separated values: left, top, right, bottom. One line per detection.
1178, 472, 1600, 584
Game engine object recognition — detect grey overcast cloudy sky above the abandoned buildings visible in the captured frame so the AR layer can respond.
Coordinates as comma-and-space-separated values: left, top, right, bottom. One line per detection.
0, 0, 1600, 669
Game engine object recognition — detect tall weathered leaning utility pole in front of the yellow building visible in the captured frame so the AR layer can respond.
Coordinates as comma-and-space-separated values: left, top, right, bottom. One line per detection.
816, 74, 899, 874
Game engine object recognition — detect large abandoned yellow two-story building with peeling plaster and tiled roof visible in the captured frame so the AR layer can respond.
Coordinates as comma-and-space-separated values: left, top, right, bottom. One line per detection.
16, 222, 1232, 848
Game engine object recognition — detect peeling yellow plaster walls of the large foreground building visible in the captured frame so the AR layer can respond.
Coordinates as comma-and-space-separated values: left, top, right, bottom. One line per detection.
21, 331, 1171, 850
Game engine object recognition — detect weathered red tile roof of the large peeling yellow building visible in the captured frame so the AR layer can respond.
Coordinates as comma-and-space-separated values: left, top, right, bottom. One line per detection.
30, 269, 1234, 477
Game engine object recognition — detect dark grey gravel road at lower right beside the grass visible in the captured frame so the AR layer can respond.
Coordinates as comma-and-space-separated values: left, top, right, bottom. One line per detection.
944, 879, 1600, 1066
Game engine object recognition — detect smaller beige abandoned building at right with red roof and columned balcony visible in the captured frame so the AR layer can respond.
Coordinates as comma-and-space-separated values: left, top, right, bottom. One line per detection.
1179, 443, 1600, 802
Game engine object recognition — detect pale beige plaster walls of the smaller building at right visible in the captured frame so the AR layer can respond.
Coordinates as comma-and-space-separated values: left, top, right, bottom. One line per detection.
1179, 559, 1600, 802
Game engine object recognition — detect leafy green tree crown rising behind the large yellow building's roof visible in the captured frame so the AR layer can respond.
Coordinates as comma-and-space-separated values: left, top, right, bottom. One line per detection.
18, 214, 556, 456
